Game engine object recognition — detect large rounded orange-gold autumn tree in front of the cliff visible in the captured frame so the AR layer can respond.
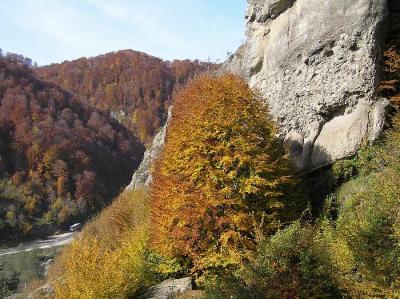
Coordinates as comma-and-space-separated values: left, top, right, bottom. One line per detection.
151, 75, 292, 272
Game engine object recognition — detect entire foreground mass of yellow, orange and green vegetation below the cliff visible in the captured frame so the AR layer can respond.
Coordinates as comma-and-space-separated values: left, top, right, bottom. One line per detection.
50, 71, 400, 298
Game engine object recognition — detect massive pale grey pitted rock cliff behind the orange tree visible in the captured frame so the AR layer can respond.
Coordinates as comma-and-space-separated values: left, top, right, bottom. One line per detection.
222, 0, 389, 169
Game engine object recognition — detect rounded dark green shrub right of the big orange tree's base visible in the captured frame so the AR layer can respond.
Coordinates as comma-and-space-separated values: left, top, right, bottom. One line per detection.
251, 221, 340, 298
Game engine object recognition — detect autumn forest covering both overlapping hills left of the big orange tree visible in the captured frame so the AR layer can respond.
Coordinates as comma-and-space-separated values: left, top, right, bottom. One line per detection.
0, 50, 215, 240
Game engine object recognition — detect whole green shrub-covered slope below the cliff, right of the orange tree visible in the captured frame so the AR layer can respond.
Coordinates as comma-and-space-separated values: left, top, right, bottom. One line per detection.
209, 116, 400, 298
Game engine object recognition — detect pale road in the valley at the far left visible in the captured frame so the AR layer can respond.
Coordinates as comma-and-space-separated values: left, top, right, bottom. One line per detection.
0, 233, 75, 257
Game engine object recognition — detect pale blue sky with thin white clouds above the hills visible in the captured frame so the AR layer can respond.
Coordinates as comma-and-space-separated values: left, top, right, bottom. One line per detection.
0, 0, 246, 65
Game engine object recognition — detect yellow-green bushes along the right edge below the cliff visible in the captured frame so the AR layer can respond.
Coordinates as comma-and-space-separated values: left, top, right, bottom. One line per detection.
323, 116, 400, 297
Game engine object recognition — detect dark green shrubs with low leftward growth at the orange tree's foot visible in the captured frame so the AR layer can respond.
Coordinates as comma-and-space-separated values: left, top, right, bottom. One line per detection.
206, 221, 342, 298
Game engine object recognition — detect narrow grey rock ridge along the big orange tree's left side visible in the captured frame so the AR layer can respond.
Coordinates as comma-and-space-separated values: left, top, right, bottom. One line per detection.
126, 106, 172, 190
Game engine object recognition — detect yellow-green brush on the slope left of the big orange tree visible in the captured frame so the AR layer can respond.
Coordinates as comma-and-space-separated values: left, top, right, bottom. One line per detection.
49, 191, 150, 299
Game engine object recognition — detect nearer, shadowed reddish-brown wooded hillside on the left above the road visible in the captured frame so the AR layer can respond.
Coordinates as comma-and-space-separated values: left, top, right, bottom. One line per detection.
0, 58, 144, 239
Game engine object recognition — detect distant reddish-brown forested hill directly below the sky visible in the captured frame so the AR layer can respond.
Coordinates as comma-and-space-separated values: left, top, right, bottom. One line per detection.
35, 50, 215, 143
